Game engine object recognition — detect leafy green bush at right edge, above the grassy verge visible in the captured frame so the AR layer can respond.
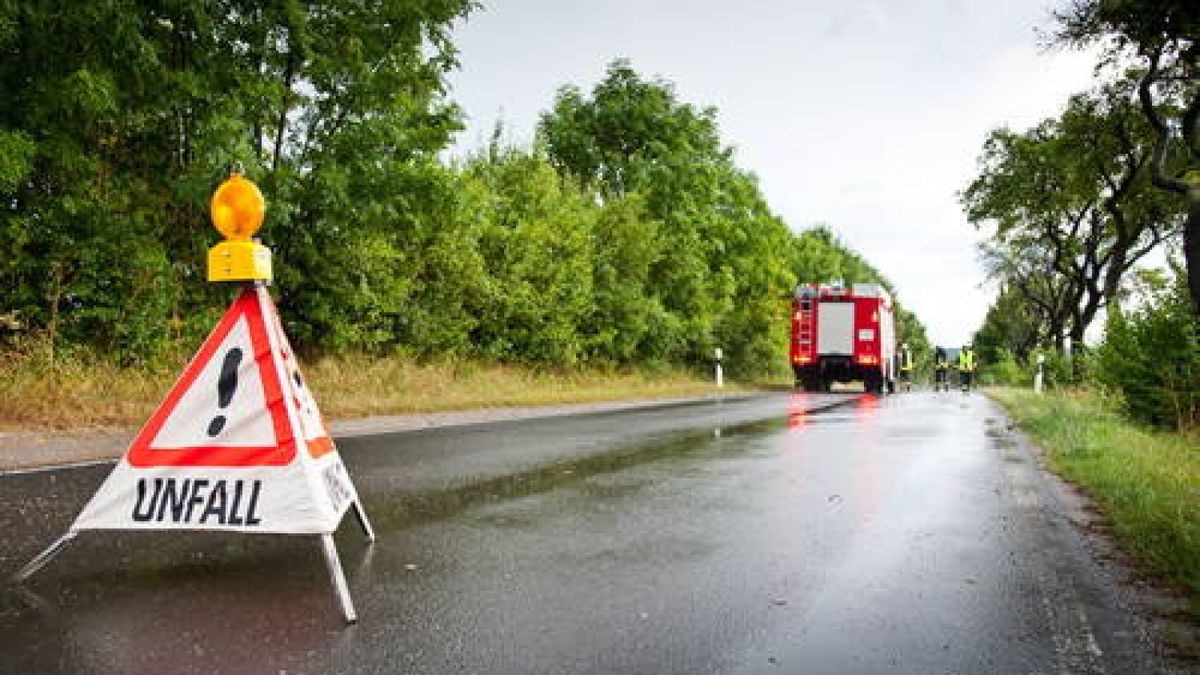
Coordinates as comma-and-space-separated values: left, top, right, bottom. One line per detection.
1094, 267, 1200, 429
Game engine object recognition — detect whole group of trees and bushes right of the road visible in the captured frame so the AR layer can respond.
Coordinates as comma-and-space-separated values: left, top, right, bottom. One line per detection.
960, 0, 1200, 428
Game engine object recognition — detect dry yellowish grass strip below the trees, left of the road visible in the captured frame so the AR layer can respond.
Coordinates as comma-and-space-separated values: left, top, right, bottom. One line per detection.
0, 345, 739, 430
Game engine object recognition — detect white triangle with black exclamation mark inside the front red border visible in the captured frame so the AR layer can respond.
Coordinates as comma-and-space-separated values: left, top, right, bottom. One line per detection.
149, 316, 277, 449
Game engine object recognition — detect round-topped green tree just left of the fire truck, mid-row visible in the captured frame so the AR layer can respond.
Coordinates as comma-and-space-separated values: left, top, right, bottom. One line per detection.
538, 60, 794, 374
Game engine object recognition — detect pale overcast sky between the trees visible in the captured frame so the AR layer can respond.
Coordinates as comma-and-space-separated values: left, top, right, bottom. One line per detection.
441, 0, 1094, 345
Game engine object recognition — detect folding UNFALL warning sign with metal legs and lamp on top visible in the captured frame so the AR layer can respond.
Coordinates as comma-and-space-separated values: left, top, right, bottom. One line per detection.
13, 169, 374, 623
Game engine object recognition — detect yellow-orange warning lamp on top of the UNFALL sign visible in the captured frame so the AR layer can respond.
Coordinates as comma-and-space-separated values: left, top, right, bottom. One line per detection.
209, 171, 271, 281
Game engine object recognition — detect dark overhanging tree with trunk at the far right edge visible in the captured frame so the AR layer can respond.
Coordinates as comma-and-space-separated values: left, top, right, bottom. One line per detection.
1054, 0, 1200, 318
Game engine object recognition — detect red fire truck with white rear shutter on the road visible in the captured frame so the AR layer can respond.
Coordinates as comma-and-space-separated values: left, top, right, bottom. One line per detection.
791, 283, 896, 393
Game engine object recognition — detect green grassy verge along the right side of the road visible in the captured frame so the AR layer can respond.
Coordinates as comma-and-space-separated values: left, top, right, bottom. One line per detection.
989, 389, 1200, 616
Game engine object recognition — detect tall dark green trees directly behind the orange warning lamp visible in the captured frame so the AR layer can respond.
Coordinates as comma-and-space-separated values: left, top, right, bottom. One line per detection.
0, 0, 472, 358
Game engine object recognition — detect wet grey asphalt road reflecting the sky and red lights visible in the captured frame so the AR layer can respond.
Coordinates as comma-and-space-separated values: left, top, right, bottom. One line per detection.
0, 393, 1160, 674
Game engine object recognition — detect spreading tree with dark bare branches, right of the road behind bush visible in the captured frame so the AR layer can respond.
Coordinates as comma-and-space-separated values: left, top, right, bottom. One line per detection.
960, 82, 1180, 348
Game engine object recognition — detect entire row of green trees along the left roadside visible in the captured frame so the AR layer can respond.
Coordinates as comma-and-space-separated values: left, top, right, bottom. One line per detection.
0, 0, 924, 376
